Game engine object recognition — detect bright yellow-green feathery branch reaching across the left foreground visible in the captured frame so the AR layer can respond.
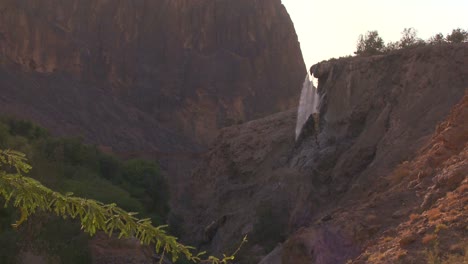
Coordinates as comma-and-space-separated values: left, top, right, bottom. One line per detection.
0, 150, 246, 264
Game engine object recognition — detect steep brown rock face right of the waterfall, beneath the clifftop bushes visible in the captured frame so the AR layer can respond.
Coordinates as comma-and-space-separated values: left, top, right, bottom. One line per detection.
292, 44, 468, 217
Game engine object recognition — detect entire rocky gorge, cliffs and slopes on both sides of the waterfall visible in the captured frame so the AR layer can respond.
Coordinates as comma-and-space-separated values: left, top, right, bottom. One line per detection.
0, 0, 468, 264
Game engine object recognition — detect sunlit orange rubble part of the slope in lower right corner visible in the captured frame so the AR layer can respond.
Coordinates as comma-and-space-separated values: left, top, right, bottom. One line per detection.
354, 94, 468, 263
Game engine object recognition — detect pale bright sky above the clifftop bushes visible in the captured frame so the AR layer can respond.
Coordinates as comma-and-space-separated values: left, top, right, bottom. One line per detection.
282, 0, 468, 67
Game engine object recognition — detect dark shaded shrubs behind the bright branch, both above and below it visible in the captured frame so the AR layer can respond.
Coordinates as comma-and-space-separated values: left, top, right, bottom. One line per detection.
0, 118, 169, 263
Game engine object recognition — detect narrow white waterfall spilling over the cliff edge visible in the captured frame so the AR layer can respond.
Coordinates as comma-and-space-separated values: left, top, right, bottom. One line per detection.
296, 73, 319, 140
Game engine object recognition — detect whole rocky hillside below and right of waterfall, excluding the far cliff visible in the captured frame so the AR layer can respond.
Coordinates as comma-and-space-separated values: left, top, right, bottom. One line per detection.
185, 44, 468, 264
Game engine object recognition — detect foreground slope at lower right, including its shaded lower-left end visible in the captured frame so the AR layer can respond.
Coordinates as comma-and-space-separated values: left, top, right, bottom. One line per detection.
282, 94, 468, 264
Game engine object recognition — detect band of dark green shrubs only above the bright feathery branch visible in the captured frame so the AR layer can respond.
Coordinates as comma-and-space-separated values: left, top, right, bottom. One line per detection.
0, 117, 169, 220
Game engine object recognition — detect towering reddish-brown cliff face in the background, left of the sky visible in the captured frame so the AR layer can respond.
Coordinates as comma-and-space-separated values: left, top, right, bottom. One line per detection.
0, 0, 305, 152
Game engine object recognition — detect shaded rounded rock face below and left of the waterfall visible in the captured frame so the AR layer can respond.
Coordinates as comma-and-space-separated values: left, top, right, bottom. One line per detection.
182, 110, 296, 253
